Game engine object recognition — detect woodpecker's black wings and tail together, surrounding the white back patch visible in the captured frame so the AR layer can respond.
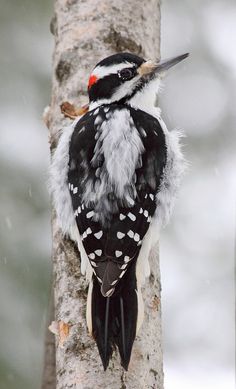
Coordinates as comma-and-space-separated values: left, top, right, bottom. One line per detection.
68, 104, 166, 370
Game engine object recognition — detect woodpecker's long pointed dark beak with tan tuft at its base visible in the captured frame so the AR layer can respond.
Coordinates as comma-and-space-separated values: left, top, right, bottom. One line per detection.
138, 53, 189, 77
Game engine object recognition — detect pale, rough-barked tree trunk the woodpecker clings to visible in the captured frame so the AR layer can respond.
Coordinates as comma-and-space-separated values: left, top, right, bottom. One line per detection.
45, 0, 163, 389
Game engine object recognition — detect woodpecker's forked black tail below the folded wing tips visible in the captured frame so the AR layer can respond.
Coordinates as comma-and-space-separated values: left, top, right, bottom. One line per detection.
87, 263, 139, 370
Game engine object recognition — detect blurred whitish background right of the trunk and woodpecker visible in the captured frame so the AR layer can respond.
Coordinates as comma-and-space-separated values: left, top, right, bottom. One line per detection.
161, 0, 236, 389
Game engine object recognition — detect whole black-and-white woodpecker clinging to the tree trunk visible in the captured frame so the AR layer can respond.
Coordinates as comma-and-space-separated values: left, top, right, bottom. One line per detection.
51, 53, 188, 370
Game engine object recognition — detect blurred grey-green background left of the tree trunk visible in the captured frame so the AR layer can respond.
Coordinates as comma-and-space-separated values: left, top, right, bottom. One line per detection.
0, 0, 53, 389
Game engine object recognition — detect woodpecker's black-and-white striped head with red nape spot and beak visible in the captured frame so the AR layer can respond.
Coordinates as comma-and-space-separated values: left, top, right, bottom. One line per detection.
88, 53, 189, 108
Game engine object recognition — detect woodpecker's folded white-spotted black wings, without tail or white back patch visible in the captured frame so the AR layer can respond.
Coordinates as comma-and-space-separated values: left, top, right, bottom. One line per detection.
68, 105, 166, 296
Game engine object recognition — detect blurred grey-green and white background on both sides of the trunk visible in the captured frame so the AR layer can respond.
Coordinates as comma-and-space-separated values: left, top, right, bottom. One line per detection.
0, 0, 236, 389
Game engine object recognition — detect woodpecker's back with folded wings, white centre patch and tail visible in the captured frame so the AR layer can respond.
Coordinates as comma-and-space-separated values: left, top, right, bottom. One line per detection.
68, 104, 166, 369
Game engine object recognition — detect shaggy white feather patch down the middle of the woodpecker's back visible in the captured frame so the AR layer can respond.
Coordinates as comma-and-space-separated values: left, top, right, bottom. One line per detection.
83, 108, 144, 209
